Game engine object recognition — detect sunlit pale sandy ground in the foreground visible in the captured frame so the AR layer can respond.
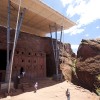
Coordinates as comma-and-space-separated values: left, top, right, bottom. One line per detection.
0, 81, 99, 100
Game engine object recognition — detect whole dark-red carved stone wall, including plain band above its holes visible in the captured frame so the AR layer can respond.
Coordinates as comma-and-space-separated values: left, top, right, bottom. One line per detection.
0, 27, 51, 83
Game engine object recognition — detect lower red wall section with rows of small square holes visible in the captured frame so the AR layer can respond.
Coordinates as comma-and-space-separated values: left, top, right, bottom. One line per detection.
12, 48, 46, 80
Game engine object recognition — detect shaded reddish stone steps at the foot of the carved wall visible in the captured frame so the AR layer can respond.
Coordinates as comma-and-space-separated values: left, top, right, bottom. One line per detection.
18, 77, 59, 92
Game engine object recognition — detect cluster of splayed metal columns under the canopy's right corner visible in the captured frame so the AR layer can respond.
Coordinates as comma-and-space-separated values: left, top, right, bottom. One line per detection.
49, 23, 63, 80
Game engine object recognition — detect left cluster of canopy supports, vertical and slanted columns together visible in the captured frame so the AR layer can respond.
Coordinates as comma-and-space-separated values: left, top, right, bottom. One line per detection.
5, 0, 25, 93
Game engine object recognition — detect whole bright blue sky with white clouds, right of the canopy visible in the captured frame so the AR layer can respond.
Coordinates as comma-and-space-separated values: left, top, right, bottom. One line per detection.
41, 0, 100, 53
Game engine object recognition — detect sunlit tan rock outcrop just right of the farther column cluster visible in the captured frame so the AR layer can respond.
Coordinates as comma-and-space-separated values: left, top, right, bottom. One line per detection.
60, 43, 75, 81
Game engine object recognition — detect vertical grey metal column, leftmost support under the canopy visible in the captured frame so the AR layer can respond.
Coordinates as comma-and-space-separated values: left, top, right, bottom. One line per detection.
5, 0, 11, 82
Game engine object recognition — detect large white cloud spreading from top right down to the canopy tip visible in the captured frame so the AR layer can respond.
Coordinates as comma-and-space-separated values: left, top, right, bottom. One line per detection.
61, 0, 100, 35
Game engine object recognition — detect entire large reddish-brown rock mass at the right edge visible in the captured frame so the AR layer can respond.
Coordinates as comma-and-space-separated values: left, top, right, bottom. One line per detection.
76, 39, 100, 90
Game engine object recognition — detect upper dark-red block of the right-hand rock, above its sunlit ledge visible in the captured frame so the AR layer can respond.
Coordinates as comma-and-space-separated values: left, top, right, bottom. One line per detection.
77, 40, 100, 60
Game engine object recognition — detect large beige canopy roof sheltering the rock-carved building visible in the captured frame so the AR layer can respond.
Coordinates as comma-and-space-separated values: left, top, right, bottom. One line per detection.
0, 0, 75, 36
